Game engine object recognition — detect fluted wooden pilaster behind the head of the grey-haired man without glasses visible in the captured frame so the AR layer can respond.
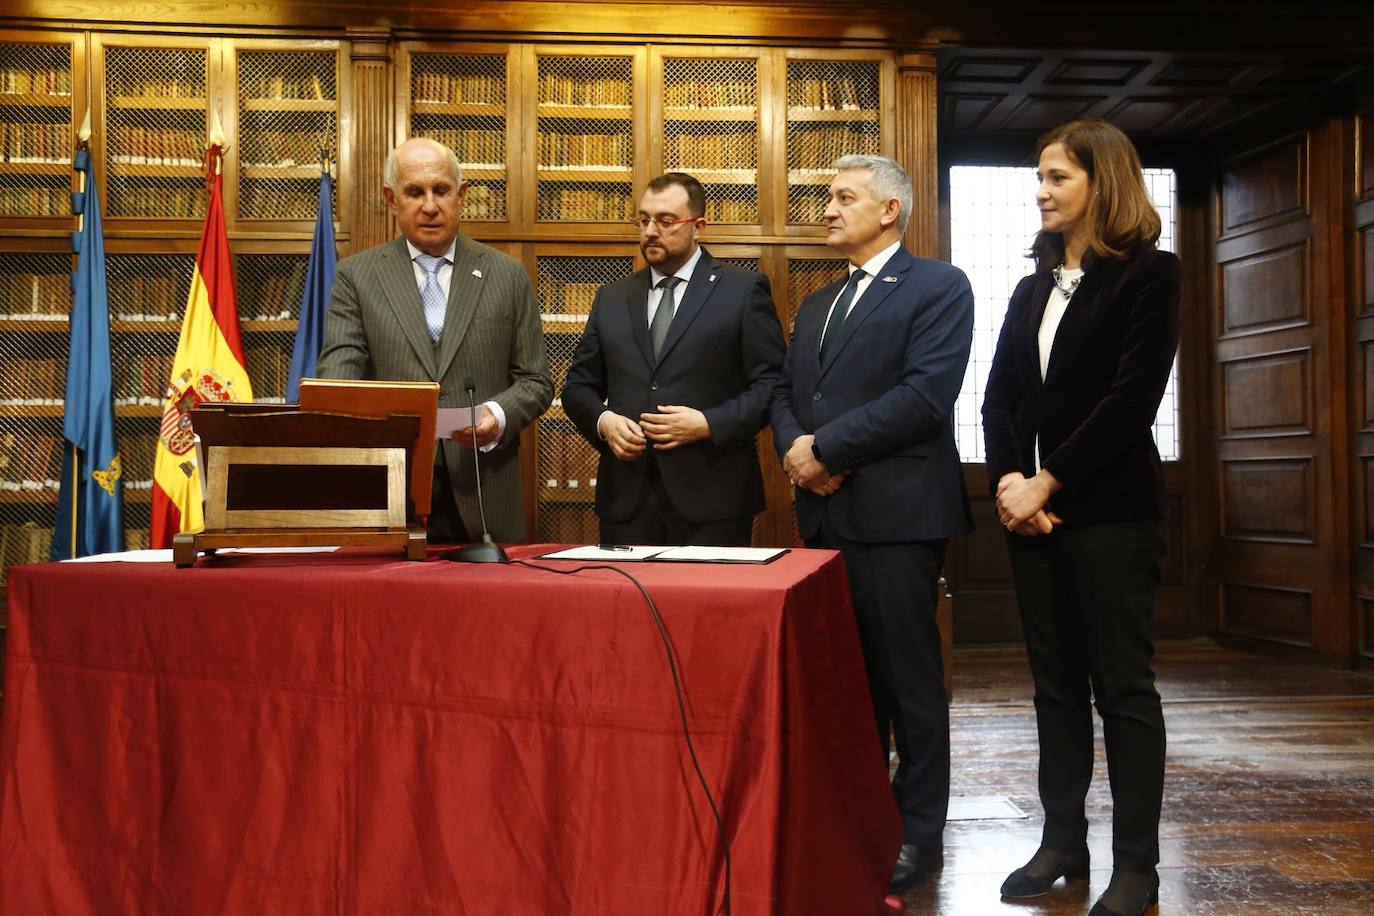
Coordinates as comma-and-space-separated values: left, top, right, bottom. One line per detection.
893, 54, 940, 258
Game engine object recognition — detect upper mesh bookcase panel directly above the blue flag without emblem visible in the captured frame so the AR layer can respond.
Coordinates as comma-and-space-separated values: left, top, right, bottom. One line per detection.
231, 47, 339, 222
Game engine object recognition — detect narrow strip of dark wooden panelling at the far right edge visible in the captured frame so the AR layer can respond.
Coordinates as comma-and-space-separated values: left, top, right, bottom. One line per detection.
1348, 108, 1374, 667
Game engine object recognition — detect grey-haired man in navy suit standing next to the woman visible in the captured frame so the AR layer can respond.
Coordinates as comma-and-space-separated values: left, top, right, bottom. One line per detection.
771, 155, 973, 893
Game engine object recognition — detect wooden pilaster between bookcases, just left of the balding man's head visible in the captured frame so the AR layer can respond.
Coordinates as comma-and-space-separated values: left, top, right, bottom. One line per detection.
348, 29, 398, 257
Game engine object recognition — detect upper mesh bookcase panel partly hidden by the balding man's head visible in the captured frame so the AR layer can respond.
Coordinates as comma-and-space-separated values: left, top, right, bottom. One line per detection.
404, 49, 511, 222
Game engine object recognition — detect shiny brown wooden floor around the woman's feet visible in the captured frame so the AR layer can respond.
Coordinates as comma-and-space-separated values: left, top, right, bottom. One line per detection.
904, 641, 1374, 916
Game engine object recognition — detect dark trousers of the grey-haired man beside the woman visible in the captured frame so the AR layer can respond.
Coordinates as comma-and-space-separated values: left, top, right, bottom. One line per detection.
807, 519, 949, 847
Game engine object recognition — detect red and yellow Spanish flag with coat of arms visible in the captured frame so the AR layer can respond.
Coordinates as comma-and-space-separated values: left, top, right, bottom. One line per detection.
148, 122, 253, 547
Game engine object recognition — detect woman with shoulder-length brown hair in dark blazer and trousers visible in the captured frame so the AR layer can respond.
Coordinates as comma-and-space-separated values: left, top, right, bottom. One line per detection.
982, 119, 1180, 916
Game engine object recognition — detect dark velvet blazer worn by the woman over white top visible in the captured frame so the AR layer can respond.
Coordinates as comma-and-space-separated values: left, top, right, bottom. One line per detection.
982, 249, 1182, 525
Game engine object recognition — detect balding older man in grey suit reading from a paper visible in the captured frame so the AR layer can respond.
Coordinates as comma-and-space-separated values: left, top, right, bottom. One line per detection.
317, 139, 554, 542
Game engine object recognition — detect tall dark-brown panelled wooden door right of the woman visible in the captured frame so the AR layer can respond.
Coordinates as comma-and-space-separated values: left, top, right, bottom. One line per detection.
1212, 125, 1349, 659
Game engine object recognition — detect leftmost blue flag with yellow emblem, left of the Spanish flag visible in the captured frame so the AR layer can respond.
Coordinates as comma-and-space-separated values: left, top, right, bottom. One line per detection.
52, 150, 124, 560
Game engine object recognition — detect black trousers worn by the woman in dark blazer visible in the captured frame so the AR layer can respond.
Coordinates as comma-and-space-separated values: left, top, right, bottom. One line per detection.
1007, 520, 1165, 872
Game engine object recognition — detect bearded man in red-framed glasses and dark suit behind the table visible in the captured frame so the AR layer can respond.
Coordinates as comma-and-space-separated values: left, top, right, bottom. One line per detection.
562, 172, 786, 547
